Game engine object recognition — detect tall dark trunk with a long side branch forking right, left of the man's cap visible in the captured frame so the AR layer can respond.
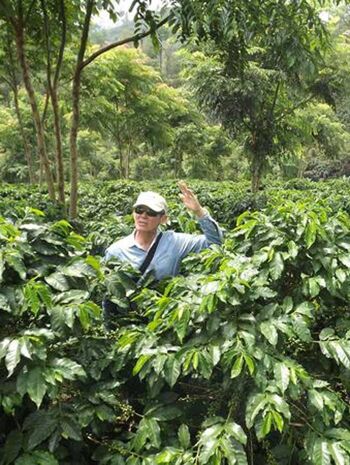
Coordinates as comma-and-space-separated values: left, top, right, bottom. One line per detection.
69, 0, 94, 219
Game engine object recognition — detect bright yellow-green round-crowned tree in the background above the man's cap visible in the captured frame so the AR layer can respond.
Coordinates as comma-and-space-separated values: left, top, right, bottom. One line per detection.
82, 47, 189, 178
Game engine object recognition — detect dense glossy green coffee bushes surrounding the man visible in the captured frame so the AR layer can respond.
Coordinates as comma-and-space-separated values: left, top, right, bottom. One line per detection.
0, 180, 350, 465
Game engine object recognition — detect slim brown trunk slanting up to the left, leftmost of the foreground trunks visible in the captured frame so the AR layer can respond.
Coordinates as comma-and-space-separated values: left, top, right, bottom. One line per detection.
15, 17, 55, 200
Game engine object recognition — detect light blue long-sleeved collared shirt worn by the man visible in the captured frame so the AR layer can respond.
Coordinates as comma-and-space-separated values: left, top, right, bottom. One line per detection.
105, 213, 223, 280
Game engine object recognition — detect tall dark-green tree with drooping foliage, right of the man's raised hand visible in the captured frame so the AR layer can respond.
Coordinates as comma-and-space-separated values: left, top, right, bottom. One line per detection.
174, 0, 327, 191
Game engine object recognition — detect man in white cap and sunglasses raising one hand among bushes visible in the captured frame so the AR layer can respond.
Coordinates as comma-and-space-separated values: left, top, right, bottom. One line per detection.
105, 182, 223, 280
